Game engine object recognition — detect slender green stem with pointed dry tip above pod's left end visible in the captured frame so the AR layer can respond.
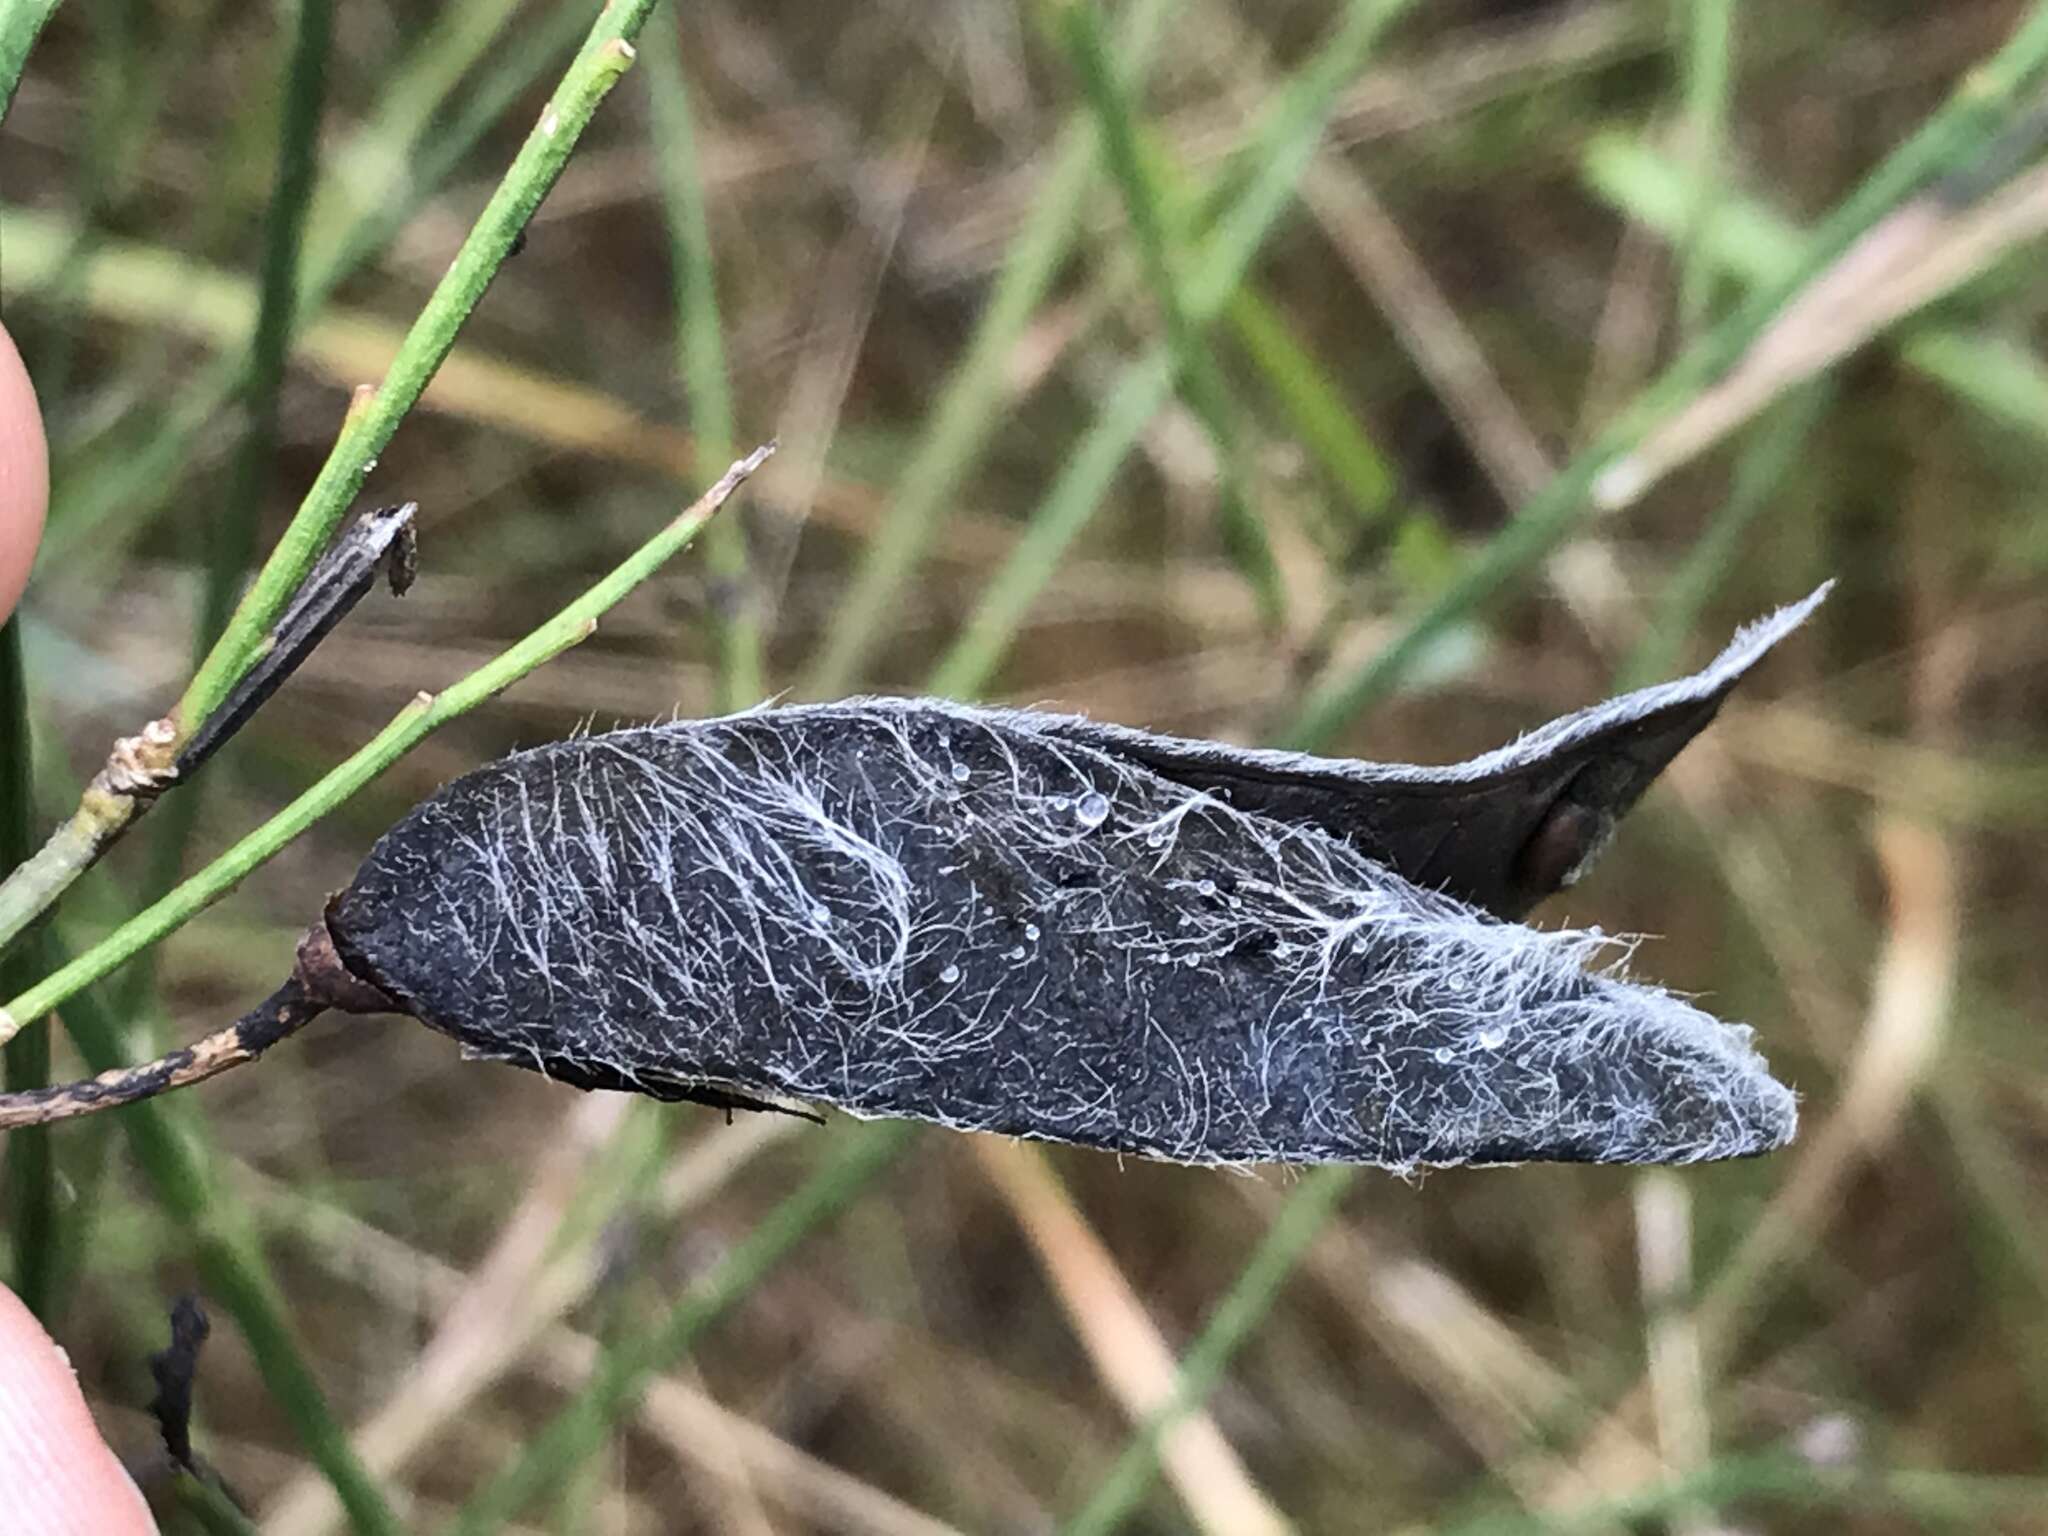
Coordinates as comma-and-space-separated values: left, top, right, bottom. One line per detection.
0, 449, 772, 1040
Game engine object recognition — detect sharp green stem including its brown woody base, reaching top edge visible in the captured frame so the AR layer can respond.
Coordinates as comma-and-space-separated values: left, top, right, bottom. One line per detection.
0, 0, 653, 962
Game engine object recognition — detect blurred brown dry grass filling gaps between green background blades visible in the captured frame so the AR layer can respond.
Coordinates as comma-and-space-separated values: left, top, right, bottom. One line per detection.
0, 0, 2048, 1536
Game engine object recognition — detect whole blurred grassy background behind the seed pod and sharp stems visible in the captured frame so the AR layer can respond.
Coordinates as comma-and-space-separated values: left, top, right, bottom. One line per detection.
0, 0, 2048, 1536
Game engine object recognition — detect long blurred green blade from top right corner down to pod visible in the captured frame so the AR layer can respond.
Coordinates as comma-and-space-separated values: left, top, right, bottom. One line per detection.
1284, 0, 2048, 752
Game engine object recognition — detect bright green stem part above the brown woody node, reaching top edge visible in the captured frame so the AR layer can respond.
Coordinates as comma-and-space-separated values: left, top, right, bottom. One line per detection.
176, 0, 653, 731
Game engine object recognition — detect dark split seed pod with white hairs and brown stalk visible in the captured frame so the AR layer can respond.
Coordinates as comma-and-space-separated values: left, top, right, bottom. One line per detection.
0, 592, 1823, 1167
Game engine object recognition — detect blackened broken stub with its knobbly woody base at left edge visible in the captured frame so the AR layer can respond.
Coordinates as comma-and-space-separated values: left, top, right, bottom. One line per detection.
0, 502, 418, 962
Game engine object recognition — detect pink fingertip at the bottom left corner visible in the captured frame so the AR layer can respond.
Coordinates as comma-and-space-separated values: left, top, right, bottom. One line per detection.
0, 1286, 156, 1536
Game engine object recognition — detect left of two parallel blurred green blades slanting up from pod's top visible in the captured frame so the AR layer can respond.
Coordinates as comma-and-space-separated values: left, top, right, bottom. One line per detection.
803, 0, 1176, 698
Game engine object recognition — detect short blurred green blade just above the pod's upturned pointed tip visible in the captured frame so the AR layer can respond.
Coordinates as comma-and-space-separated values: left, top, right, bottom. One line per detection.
1614, 381, 1833, 692
